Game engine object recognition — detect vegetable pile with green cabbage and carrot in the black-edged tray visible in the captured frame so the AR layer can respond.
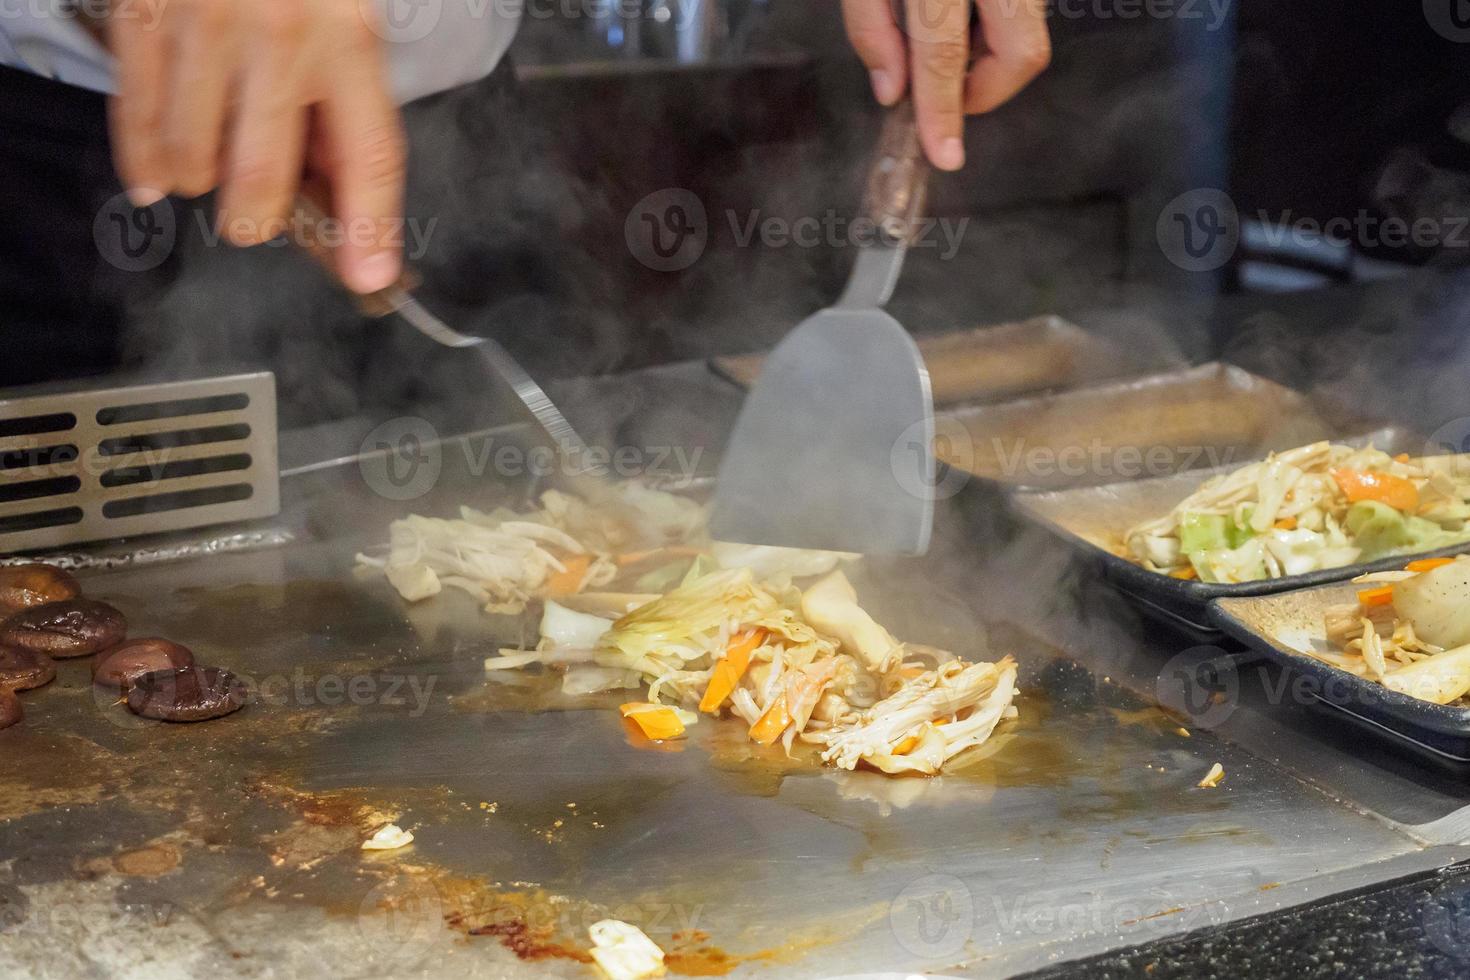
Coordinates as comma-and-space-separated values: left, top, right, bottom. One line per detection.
1125, 442, 1470, 582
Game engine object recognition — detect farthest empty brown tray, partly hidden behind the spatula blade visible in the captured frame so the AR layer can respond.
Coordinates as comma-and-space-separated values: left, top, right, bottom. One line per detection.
711, 316, 1163, 406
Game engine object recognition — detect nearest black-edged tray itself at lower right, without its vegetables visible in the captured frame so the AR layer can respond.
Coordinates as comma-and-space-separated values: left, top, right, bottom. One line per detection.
1210, 578, 1470, 763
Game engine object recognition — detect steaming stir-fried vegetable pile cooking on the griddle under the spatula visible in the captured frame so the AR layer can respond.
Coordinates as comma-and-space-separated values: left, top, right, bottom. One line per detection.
359, 489, 1016, 774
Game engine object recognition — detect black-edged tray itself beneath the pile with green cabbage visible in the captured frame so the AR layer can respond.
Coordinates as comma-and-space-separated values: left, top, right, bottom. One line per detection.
1011, 429, 1446, 635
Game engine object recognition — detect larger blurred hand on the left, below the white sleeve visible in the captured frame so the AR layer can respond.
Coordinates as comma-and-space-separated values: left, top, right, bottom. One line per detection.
106, 0, 404, 292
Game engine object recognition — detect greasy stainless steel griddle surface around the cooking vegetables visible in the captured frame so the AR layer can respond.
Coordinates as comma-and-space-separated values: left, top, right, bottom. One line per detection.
0, 364, 1464, 977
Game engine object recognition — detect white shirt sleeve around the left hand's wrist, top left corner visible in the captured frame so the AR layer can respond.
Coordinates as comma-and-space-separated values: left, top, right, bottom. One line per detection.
0, 0, 522, 104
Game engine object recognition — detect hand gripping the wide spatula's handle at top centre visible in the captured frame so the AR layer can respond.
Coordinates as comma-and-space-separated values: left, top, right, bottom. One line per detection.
842, 0, 1051, 170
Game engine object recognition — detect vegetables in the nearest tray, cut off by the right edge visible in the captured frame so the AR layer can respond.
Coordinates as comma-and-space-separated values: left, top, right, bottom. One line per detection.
1307, 555, 1470, 707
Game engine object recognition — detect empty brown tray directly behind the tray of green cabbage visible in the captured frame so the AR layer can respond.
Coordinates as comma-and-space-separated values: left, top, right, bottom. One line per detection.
938, 363, 1333, 489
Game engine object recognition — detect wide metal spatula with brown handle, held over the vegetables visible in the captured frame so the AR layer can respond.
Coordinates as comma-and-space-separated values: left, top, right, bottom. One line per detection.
710, 103, 935, 555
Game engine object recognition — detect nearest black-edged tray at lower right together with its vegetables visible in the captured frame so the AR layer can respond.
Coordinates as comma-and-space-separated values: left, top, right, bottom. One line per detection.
1210, 558, 1470, 763
